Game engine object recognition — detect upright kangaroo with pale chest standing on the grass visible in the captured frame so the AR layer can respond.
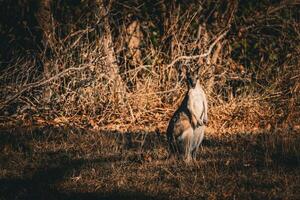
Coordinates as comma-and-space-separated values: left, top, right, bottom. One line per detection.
167, 69, 208, 162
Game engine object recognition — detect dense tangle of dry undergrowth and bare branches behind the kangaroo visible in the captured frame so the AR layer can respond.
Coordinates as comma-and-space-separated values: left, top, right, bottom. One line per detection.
0, 0, 300, 132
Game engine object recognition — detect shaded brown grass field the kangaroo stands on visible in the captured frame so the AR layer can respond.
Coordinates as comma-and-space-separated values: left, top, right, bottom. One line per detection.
0, 126, 300, 199
